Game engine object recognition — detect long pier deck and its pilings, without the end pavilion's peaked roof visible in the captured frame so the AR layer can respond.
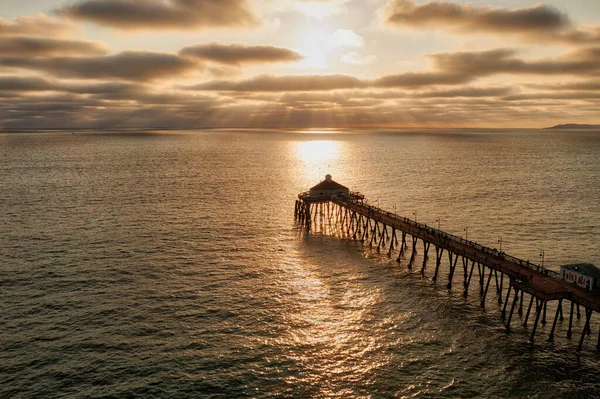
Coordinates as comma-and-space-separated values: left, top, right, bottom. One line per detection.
295, 187, 600, 351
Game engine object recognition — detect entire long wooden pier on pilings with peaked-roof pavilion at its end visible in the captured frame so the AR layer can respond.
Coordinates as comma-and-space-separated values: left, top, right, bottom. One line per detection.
294, 175, 600, 352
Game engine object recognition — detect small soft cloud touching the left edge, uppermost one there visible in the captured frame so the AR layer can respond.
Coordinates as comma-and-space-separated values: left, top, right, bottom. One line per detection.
0, 14, 73, 37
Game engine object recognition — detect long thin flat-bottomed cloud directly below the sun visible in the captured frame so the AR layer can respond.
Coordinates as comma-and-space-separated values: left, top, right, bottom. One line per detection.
186, 75, 366, 92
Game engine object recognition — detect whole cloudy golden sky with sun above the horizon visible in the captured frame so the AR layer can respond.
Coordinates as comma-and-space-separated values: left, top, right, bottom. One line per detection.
0, 0, 600, 130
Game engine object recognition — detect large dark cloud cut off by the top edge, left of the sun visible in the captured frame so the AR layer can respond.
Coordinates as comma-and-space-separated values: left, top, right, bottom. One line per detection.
57, 0, 260, 30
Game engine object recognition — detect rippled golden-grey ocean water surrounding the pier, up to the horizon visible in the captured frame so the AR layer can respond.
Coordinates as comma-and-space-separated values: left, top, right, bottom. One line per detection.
0, 130, 600, 398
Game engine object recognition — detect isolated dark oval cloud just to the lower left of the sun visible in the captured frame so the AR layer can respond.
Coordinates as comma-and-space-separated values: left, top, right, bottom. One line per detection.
179, 43, 302, 66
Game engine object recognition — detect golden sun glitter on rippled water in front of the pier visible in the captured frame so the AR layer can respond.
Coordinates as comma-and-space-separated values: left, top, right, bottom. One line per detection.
276, 255, 396, 398
